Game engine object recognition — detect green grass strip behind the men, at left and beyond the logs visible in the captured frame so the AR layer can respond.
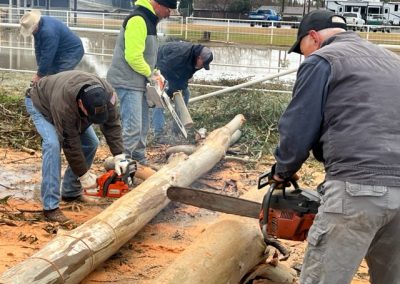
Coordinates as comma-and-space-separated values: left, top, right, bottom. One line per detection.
0, 72, 292, 159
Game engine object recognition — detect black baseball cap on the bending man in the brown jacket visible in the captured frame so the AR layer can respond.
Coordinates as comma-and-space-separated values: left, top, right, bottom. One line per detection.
80, 85, 110, 124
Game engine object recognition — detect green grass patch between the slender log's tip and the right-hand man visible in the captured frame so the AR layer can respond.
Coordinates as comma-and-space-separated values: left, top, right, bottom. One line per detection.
189, 81, 291, 157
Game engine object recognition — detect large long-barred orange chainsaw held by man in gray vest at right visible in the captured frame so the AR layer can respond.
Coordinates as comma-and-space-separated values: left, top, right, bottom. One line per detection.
167, 174, 320, 260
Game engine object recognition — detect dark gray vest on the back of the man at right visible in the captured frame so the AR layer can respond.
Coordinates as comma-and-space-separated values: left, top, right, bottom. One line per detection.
313, 32, 400, 186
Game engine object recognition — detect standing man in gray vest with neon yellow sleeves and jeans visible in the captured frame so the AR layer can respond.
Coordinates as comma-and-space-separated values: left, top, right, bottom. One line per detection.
107, 0, 176, 164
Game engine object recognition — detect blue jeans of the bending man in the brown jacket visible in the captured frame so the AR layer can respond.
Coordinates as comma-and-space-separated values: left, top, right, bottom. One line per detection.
25, 98, 99, 210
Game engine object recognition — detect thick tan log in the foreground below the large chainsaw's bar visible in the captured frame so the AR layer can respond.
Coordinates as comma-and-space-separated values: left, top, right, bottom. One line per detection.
154, 187, 296, 284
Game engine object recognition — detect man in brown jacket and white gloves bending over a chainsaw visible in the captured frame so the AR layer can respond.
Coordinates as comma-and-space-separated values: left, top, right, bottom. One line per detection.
25, 71, 127, 223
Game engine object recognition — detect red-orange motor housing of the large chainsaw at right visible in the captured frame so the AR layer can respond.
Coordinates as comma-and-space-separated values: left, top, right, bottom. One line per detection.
260, 208, 315, 241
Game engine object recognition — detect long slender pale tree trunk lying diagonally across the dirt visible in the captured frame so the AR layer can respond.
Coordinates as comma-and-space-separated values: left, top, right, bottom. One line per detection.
0, 115, 244, 284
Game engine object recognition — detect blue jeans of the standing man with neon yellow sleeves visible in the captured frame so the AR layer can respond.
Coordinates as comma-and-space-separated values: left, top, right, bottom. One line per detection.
115, 88, 149, 164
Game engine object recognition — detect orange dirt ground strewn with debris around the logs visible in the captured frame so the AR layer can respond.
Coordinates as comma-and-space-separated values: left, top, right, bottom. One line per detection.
0, 147, 368, 284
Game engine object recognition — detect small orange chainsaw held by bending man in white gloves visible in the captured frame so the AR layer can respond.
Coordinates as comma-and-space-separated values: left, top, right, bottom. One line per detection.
84, 161, 137, 198
